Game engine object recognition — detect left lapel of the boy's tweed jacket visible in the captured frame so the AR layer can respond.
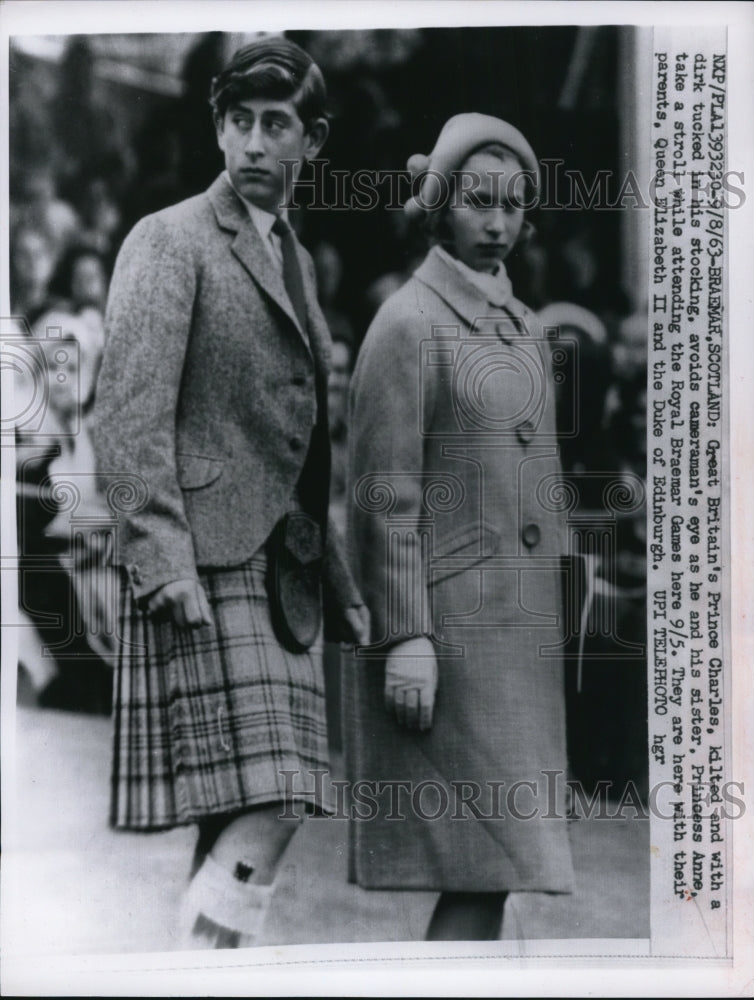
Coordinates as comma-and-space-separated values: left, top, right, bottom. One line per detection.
207, 174, 309, 354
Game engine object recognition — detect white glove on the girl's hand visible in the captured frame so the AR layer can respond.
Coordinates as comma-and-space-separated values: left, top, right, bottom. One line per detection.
385, 636, 437, 731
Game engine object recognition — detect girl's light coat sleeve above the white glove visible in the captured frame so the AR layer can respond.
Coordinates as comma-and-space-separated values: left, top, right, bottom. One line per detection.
348, 294, 437, 648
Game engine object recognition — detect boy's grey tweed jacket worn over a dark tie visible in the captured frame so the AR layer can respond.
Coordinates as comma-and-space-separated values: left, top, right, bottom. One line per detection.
94, 175, 359, 620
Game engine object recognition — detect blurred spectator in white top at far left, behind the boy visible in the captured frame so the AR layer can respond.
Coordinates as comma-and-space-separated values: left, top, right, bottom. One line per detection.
16, 310, 112, 714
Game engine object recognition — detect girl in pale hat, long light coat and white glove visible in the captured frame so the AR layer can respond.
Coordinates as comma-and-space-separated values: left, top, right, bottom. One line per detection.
344, 114, 573, 940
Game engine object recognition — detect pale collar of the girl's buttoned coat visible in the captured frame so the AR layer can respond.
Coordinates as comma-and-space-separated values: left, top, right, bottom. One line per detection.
414, 247, 532, 341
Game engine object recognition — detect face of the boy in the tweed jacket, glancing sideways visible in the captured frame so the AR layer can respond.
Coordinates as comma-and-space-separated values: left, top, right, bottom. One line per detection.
217, 97, 327, 215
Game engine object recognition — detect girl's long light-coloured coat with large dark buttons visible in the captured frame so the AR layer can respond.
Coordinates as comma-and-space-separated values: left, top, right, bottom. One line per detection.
344, 250, 572, 892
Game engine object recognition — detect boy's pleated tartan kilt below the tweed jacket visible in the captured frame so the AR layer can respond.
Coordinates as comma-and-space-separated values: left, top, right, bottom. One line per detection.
110, 552, 330, 830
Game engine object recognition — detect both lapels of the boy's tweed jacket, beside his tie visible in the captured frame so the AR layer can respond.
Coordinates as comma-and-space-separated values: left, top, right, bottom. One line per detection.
207, 174, 330, 369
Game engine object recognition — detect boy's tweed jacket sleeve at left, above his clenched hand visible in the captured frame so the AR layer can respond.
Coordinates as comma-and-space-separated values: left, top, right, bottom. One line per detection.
94, 216, 197, 599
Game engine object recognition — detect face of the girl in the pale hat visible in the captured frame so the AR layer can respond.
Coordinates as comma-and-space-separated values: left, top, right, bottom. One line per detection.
447, 152, 526, 272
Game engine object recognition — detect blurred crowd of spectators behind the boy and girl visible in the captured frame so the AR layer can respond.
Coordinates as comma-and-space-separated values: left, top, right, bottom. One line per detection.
9, 29, 647, 796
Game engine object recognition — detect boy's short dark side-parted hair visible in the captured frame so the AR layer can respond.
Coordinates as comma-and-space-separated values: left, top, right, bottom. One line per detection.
210, 36, 327, 128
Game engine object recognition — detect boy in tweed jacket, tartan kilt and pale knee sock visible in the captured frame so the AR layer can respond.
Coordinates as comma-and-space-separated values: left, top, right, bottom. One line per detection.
95, 37, 367, 947
